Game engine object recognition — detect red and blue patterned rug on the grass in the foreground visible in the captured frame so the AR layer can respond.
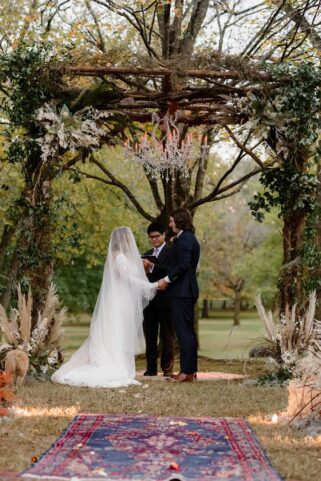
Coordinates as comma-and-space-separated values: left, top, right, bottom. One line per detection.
23, 414, 281, 481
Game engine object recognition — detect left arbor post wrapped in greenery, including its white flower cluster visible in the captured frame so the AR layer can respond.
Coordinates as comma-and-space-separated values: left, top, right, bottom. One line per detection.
0, 44, 115, 316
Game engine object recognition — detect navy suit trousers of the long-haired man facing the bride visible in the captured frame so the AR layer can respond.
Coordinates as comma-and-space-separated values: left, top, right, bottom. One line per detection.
170, 297, 197, 374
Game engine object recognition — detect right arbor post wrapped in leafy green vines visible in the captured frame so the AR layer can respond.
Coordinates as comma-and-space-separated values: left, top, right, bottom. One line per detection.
245, 63, 321, 309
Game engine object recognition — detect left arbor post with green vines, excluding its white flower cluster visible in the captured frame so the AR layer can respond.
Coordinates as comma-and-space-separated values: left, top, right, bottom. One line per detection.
0, 45, 60, 316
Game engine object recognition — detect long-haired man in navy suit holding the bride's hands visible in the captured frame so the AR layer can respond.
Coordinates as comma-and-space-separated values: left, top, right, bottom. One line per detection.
158, 208, 200, 382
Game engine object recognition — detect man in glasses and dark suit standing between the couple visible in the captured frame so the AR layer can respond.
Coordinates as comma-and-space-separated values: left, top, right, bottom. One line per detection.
143, 222, 175, 377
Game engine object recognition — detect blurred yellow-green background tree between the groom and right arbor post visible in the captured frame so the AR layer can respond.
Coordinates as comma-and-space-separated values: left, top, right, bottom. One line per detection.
196, 185, 282, 324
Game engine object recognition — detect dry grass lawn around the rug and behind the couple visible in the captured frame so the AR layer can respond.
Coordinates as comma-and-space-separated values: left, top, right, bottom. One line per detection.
0, 312, 321, 481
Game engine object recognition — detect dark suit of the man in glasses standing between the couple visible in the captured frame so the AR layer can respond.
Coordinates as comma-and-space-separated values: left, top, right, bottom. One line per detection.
143, 244, 175, 374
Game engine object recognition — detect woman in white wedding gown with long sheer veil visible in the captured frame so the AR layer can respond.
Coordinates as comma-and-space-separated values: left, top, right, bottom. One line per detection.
51, 227, 158, 387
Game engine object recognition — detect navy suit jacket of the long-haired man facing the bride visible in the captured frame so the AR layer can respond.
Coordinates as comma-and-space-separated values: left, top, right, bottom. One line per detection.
166, 230, 200, 299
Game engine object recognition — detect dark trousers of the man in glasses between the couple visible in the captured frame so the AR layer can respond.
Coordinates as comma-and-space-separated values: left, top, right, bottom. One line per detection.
143, 302, 175, 374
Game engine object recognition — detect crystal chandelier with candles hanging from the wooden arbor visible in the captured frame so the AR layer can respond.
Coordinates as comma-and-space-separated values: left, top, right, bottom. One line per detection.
124, 112, 207, 181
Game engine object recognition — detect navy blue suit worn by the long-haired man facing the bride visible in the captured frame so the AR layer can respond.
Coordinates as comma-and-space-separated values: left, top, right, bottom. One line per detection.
166, 230, 200, 374
